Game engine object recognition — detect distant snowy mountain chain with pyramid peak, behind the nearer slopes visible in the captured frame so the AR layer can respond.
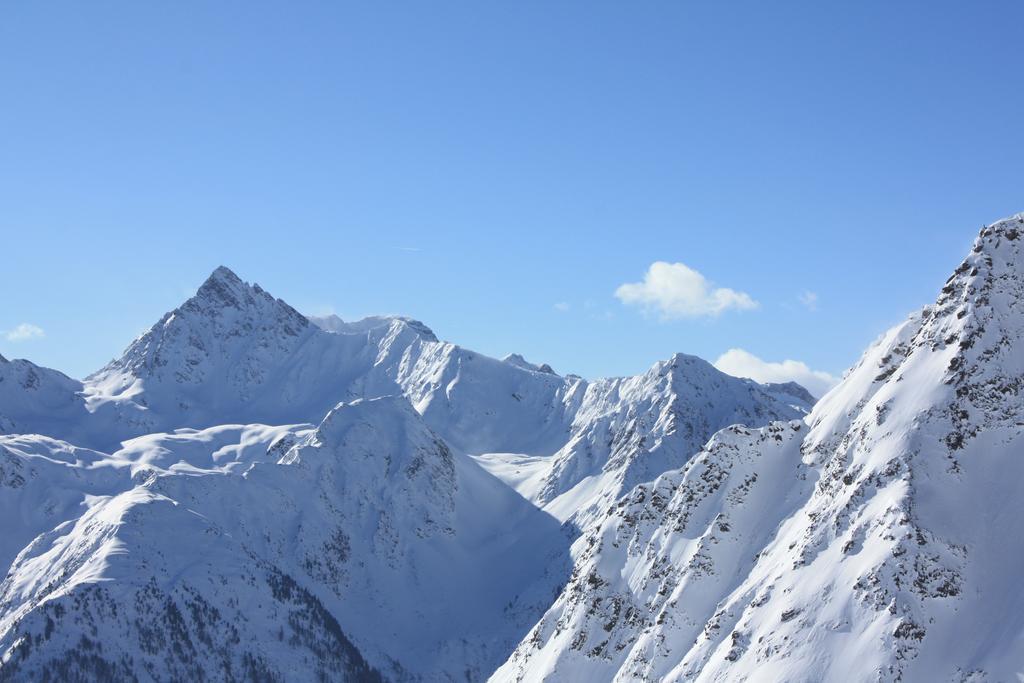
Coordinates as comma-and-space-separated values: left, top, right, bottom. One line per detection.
0, 267, 798, 501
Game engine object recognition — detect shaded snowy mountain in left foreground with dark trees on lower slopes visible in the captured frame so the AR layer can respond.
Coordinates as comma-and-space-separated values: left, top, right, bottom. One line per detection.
0, 397, 568, 680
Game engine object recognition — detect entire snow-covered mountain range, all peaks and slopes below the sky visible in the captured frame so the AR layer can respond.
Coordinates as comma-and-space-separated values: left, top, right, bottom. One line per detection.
0, 216, 1024, 681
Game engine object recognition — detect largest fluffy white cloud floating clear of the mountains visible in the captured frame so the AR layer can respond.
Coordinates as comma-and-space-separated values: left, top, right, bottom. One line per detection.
615, 261, 758, 319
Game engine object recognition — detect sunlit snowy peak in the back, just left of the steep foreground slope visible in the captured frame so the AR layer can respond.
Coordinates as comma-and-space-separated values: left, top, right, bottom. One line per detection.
491, 353, 809, 527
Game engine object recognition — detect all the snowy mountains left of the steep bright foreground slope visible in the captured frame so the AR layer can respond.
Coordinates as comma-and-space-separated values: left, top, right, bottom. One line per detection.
0, 267, 815, 681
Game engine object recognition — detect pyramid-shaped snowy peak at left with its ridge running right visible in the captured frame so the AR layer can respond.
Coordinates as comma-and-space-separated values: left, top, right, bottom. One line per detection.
64, 267, 579, 452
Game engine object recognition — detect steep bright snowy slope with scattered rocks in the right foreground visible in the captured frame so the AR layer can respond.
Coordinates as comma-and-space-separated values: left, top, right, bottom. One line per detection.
494, 216, 1024, 681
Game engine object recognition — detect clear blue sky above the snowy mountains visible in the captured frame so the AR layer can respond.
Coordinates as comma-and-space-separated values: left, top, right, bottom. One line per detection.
0, 2, 1024, 389
